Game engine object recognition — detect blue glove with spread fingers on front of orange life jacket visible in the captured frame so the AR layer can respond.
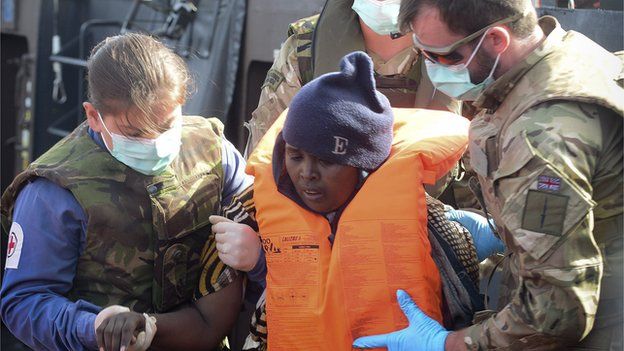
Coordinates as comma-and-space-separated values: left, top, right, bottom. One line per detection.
353, 290, 450, 351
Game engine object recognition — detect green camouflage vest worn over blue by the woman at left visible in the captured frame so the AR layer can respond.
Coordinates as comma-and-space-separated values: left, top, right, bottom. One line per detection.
2, 116, 223, 312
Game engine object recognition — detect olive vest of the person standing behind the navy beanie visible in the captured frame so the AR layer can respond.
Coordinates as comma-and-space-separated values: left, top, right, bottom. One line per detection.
288, 1, 422, 108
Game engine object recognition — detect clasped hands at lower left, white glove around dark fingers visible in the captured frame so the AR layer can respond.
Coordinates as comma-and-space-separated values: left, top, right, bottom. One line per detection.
95, 306, 157, 351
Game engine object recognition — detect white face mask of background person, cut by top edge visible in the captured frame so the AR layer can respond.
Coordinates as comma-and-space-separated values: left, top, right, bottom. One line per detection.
351, 0, 401, 35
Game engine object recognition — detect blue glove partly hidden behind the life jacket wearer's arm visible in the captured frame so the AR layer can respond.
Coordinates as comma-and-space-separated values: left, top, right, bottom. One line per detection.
445, 209, 505, 261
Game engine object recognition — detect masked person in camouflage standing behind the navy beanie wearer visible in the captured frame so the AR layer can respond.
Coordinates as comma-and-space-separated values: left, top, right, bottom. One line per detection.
245, 0, 479, 208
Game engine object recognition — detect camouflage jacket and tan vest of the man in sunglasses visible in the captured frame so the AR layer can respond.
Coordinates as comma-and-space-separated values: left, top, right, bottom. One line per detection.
465, 17, 624, 350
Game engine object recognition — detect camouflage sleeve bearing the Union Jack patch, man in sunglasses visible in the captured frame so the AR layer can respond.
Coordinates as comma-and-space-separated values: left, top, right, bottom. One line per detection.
464, 102, 608, 350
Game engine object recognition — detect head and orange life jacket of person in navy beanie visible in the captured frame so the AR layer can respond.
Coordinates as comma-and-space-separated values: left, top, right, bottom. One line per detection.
213, 52, 468, 350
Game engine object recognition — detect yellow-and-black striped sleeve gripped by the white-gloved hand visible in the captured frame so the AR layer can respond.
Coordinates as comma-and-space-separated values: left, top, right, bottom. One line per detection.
195, 185, 258, 299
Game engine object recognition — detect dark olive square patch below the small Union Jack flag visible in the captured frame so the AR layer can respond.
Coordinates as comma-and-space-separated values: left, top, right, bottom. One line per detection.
522, 188, 569, 236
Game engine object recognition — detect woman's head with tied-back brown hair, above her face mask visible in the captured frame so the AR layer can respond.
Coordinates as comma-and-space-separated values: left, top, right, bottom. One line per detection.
87, 33, 191, 131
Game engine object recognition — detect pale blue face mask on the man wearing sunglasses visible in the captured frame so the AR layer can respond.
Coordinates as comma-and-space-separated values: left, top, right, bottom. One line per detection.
425, 32, 500, 101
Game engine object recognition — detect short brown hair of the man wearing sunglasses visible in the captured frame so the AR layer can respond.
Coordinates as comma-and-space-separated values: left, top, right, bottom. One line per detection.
399, 0, 537, 38
